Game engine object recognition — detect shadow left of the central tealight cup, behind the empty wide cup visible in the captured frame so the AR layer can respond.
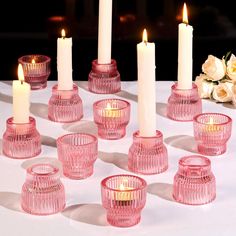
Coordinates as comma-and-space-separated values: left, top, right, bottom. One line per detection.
62, 120, 98, 136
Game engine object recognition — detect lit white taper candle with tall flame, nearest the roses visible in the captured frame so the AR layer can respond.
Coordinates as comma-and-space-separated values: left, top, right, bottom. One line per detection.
178, 3, 193, 89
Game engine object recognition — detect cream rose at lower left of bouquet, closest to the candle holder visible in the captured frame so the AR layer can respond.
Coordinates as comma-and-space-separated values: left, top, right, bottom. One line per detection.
195, 74, 214, 98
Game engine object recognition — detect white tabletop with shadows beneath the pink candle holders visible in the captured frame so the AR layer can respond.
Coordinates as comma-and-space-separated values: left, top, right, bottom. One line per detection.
0, 81, 236, 236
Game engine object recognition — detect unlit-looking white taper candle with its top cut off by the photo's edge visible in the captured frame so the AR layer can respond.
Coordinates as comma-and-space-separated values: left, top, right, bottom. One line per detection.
98, 0, 112, 64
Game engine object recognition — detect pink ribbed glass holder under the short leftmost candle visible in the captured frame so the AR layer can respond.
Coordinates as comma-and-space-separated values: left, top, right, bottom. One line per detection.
2, 117, 41, 159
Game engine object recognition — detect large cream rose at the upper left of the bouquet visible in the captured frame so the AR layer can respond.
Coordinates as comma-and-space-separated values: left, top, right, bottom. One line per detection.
202, 55, 226, 81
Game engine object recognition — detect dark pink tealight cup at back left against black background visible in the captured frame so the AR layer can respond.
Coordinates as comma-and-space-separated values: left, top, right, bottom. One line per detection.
18, 54, 51, 90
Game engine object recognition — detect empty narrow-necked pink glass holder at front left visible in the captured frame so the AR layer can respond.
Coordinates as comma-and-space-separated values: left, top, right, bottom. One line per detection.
21, 164, 66, 215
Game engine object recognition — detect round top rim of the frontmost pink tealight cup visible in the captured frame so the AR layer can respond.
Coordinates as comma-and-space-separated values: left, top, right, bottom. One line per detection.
101, 174, 147, 192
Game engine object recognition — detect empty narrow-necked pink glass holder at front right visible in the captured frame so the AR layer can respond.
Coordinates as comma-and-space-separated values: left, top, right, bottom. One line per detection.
173, 155, 216, 205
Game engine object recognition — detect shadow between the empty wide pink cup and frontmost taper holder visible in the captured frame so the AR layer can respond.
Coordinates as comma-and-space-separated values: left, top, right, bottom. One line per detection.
98, 151, 128, 171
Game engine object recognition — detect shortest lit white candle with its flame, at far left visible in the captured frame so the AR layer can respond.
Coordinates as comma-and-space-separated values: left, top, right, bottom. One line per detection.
12, 64, 30, 124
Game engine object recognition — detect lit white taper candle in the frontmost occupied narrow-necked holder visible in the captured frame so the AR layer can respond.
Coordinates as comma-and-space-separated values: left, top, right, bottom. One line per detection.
137, 30, 156, 137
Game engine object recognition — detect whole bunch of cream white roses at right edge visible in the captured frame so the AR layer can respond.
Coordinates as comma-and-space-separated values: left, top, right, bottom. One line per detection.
195, 52, 236, 105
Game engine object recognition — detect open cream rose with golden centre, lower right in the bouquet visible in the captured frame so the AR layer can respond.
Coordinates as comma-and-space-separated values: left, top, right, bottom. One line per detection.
212, 82, 233, 102
